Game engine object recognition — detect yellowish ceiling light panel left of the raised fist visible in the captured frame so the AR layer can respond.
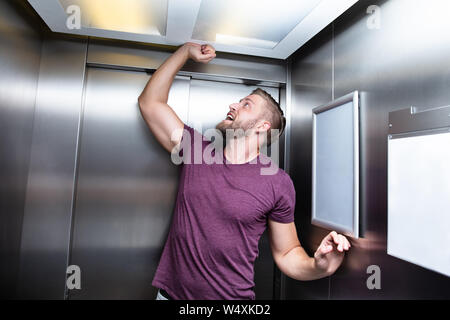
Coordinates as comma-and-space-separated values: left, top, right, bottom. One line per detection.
59, 0, 168, 36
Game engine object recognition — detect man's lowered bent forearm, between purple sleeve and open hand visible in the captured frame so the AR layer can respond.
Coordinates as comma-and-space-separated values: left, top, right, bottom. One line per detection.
278, 246, 329, 281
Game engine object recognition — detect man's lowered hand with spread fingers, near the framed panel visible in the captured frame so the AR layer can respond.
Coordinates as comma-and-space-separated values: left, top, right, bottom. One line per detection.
314, 231, 351, 275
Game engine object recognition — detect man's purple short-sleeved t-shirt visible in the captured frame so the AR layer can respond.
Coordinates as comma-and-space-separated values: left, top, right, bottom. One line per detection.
152, 124, 295, 300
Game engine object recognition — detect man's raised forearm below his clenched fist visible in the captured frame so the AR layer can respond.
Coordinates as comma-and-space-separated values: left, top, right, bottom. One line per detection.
139, 45, 189, 104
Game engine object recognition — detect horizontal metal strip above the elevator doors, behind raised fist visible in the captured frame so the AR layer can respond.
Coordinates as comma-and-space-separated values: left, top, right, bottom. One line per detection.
87, 39, 286, 83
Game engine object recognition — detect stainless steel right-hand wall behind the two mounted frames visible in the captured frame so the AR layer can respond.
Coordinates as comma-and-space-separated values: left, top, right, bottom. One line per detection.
285, 0, 450, 299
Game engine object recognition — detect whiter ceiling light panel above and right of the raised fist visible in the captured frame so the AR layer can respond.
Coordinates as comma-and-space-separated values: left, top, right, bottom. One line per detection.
192, 0, 321, 49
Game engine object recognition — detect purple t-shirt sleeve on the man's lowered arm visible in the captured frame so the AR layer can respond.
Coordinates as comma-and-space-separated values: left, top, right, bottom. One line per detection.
268, 174, 295, 223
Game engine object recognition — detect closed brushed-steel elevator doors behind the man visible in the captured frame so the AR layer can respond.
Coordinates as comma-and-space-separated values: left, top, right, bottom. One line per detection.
68, 68, 278, 299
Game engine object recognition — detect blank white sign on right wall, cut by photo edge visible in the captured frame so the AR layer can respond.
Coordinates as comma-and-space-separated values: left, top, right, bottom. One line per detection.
387, 130, 450, 276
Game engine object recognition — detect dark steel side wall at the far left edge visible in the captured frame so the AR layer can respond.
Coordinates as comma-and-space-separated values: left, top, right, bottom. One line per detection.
0, 0, 42, 298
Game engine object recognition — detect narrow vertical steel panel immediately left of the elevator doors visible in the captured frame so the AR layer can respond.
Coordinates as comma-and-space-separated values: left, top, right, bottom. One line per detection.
18, 37, 87, 299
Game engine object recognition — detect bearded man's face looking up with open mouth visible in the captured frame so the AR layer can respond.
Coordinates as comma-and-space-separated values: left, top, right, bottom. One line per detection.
216, 94, 265, 137
